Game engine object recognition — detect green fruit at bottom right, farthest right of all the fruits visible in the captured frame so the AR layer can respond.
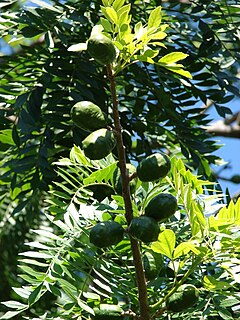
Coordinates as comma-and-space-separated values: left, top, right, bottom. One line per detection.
166, 284, 199, 312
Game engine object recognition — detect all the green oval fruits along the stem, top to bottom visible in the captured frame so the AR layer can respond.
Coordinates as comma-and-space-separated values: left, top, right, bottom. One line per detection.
71, 33, 199, 320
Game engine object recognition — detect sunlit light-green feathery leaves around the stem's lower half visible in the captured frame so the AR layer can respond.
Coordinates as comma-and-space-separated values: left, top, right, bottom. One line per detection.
2, 147, 240, 319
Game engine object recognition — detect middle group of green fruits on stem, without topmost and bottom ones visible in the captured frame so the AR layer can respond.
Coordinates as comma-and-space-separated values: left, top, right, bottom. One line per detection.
71, 101, 177, 247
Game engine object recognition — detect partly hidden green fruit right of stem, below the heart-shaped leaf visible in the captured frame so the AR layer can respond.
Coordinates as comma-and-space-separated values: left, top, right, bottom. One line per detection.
143, 251, 163, 280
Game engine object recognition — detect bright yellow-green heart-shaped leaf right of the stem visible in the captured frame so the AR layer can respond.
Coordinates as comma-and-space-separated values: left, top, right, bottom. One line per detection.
151, 229, 176, 260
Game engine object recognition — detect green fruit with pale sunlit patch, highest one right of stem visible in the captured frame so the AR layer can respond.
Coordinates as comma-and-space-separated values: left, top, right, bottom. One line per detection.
137, 152, 171, 182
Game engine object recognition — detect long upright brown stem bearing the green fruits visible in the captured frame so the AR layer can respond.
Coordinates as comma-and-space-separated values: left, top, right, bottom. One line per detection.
107, 65, 150, 320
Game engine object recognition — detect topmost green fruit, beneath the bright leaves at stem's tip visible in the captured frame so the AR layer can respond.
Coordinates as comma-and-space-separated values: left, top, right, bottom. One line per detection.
87, 33, 116, 65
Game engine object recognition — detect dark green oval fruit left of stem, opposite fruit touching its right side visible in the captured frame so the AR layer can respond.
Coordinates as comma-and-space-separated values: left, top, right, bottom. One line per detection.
90, 220, 124, 248
